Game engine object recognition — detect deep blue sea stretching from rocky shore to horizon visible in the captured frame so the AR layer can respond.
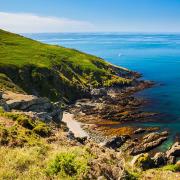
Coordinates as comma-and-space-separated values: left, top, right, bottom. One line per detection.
26, 33, 180, 148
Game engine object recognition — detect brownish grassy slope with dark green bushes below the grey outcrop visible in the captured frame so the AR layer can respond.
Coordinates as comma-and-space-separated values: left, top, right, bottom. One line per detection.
0, 108, 51, 147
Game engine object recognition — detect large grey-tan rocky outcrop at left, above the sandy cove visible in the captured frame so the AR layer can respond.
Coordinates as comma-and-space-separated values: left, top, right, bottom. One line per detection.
0, 91, 63, 123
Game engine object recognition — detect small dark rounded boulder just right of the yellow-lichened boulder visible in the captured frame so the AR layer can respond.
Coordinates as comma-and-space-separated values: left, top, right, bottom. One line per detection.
153, 152, 167, 167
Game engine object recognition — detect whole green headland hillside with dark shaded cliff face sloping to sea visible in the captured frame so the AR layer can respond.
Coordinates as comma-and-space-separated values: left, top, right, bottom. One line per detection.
0, 30, 131, 101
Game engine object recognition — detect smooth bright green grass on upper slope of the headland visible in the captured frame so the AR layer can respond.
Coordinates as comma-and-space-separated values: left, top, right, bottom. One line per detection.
0, 30, 104, 69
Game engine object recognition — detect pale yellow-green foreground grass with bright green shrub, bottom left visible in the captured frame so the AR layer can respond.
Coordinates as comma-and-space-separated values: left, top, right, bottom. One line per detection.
0, 144, 91, 180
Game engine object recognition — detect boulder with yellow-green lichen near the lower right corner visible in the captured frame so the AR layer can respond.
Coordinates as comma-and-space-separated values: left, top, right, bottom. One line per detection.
131, 153, 155, 170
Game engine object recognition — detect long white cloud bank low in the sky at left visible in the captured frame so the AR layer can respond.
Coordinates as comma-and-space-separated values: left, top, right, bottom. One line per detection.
0, 12, 94, 33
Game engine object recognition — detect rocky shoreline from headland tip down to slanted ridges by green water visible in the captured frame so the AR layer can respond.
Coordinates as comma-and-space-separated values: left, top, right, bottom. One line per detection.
65, 80, 172, 154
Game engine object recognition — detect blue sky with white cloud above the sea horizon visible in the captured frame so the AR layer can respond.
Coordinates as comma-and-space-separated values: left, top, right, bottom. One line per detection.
0, 0, 180, 32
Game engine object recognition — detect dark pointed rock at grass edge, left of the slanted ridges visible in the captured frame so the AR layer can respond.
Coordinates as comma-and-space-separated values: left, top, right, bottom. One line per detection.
104, 135, 130, 149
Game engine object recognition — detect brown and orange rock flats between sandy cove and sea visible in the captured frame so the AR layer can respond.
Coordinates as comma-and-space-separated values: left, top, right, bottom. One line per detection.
68, 81, 158, 139
